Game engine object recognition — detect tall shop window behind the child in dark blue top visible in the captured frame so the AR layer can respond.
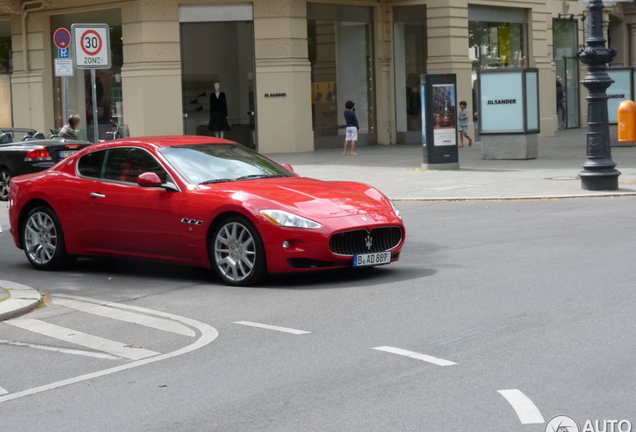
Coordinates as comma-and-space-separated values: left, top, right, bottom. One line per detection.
307, 3, 376, 149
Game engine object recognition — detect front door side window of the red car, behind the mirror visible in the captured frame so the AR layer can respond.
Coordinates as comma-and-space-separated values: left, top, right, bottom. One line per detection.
103, 147, 168, 183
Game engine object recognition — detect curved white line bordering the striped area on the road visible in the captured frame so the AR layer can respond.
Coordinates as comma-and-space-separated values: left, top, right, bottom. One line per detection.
0, 295, 219, 403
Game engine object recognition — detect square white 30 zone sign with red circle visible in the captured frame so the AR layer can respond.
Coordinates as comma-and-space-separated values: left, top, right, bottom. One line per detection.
71, 24, 110, 69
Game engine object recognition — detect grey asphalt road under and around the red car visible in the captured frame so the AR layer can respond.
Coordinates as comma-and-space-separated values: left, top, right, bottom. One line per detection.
0, 198, 636, 432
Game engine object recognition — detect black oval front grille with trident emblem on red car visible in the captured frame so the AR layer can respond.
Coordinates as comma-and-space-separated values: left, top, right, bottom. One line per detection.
329, 227, 402, 256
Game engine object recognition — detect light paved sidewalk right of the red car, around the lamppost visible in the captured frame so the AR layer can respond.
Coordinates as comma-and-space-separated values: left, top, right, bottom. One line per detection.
267, 129, 636, 200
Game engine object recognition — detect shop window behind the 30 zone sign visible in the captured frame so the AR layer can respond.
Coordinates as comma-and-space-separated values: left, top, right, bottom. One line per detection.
50, 9, 125, 140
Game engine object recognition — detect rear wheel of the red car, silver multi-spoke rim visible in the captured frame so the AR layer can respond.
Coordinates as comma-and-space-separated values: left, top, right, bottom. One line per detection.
22, 206, 72, 270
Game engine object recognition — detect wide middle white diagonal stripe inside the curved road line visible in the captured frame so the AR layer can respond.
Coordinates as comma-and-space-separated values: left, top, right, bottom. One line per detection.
7, 318, 159, 360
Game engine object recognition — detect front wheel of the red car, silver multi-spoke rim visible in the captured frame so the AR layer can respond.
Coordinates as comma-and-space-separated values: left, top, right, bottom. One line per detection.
210, 216, 266, 286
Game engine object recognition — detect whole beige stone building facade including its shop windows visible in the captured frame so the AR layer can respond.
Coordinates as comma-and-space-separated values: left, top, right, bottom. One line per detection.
0, 0, 636, 153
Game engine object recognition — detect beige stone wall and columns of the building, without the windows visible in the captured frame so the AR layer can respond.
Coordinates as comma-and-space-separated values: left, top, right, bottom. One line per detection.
0, 0, 636, 152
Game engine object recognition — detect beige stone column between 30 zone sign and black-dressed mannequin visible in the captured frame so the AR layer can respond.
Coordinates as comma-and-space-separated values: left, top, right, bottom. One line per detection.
121, 0, 183, 136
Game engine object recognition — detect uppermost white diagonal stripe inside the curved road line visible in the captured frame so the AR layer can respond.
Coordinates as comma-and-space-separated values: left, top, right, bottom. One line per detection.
53, 298, 194, 337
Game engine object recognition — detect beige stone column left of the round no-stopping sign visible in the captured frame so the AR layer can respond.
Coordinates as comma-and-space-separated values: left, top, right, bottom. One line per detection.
11, 12, 54, 135
